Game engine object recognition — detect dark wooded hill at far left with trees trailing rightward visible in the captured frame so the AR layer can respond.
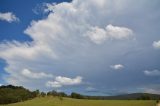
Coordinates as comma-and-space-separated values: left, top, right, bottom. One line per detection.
0, 85, 67, 104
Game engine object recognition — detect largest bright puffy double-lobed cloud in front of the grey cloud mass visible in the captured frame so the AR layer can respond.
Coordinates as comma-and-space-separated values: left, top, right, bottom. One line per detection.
86, 24, 133, 44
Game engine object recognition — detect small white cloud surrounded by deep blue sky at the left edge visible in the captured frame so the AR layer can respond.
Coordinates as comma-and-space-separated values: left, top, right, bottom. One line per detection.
0, 12, 19, 23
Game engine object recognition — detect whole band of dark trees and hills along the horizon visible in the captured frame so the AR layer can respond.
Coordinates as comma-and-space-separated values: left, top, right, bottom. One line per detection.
0, 85, 160, 104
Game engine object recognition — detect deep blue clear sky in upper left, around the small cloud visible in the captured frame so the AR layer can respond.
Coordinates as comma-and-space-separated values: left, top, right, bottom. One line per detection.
0, 0, 69, 42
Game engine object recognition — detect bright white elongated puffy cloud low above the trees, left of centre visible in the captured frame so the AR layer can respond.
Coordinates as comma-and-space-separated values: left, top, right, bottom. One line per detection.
46, 76, 82, 88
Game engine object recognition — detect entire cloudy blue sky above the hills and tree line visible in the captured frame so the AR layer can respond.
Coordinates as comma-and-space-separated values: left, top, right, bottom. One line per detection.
0, 0, 160, 96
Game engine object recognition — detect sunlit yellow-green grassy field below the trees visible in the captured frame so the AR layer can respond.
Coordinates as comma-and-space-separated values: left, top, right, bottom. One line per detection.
0, 97, 156, 106
